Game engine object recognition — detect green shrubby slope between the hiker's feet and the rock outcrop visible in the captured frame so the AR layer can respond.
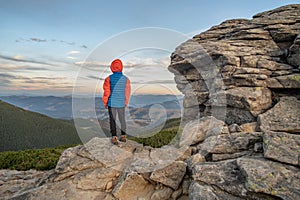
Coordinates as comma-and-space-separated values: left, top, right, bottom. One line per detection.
129, 119, 180, 148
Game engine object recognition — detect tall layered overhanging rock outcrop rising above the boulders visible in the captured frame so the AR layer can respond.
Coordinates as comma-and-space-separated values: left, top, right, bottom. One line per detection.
169, 5, 300, 124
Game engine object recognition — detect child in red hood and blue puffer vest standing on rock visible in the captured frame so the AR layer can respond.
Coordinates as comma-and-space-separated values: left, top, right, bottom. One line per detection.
102, 59, 131, 144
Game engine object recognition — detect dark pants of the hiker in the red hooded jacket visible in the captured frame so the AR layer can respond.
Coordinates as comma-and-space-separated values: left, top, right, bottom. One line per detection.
108, 107, 126, 136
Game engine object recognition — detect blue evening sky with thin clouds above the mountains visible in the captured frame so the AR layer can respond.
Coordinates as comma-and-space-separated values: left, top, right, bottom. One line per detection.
0, 0, 298, 96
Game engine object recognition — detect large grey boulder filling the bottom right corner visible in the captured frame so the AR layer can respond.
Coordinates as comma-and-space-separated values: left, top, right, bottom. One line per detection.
237, 158, 300, 200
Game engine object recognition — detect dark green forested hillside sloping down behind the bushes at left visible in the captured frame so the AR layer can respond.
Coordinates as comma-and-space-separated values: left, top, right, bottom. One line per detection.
0, 101, 81, 152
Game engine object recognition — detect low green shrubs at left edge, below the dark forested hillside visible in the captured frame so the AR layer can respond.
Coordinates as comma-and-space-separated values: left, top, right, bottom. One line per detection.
0, 145, 74, 170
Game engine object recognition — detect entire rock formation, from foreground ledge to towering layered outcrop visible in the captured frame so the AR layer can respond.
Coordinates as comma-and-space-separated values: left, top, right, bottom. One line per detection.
0, 5, 300, 200
